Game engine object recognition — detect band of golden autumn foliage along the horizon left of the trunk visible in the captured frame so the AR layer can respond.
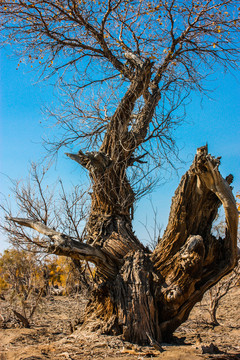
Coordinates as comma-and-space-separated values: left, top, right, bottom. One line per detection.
0, 249, 82, 294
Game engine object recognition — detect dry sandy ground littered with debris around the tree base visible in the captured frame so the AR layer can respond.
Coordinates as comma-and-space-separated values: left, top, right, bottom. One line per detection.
0, 286, 240, 360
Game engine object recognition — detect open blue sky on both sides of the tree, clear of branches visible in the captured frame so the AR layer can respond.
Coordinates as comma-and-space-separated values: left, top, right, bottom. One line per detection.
0, 50, 240, 252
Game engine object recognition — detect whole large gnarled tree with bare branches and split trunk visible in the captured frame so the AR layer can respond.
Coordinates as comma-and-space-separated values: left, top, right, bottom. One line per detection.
0, 0, 239, 343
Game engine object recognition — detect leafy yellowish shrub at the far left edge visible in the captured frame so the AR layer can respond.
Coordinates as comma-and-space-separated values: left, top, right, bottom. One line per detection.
0, 249, 45, 328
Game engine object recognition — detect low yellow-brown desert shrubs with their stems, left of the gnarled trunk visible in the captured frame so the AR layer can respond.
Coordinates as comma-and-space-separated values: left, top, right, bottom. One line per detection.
0, 248, 90, 328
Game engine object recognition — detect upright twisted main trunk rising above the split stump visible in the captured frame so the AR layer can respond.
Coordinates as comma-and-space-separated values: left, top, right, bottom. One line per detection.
67, 57, 156, 267
